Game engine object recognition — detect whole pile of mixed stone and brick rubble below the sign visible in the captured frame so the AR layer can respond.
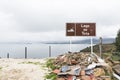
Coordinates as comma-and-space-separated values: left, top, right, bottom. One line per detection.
53, 52, 112, 80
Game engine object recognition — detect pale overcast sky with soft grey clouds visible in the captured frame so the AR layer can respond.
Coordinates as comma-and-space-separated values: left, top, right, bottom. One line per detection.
0, 0, 120, 42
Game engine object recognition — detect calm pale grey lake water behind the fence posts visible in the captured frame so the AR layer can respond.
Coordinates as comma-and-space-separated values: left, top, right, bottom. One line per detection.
0, 44, 90, 58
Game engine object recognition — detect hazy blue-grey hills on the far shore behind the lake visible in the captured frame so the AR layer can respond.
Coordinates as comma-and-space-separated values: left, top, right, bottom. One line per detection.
44, 38, 115, 44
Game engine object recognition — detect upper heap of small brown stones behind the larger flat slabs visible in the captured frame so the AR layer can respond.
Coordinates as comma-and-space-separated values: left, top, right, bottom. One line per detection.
55, 52, 98, 66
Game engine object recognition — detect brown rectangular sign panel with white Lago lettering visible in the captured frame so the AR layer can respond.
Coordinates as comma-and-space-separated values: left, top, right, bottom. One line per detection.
66, 23, 96, 36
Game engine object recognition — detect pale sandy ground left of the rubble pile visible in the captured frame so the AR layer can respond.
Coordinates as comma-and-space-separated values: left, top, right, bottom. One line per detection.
0, 59, 48, 80
